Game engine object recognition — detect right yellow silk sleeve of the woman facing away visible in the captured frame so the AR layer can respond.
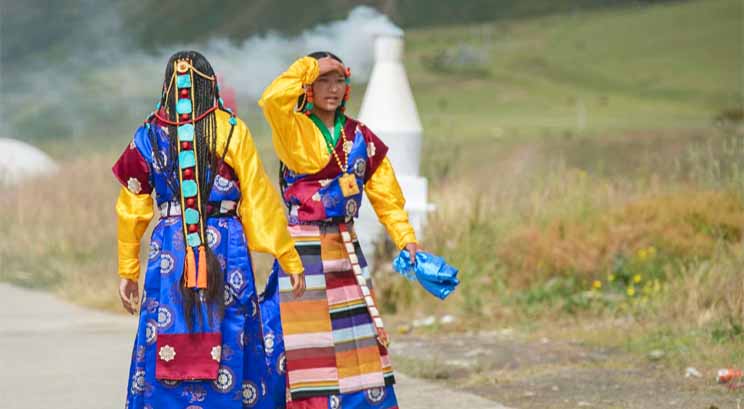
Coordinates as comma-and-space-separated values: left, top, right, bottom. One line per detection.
218, 115, 304, 274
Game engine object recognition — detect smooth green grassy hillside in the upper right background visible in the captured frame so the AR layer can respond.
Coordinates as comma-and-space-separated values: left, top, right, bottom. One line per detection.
406, 0, 744, 143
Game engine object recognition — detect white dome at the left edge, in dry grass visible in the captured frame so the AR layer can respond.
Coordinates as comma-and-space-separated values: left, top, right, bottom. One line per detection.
0, 138, 57, 185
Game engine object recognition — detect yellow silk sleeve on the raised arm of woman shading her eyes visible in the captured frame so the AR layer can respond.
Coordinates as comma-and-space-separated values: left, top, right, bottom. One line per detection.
258, 57, 330, 174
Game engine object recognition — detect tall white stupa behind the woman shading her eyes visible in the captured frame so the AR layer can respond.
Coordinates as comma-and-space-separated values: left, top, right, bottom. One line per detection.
356, 32, 433, 260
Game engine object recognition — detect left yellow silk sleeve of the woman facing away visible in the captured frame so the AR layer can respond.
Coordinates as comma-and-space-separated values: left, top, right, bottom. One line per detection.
116, 187, 154, 281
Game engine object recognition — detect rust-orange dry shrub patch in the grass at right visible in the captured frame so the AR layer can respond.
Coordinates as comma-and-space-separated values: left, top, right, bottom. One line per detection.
498, 190, 744, 288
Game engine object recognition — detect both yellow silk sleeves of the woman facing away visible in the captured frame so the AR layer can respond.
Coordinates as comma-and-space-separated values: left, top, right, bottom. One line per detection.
116, 111, 303, 278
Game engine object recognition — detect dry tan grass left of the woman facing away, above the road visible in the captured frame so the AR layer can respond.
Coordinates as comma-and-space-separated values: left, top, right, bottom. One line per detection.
0, 154, 119, 307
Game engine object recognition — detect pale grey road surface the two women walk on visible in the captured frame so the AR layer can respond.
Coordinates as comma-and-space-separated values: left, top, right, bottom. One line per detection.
0, 284, 504, 409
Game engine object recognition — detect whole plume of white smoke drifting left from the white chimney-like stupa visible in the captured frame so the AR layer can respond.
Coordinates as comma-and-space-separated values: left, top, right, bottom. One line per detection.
0, 6, 402, 143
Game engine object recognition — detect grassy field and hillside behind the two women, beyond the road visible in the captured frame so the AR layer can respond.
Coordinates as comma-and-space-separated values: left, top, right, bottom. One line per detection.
0, 0, 744, 367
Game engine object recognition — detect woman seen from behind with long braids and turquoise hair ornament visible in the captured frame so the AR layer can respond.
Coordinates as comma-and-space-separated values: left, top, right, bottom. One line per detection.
113, 51, 305, 409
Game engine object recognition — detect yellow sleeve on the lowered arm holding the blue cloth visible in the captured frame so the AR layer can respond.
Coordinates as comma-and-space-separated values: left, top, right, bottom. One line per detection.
364, 157, 417, 249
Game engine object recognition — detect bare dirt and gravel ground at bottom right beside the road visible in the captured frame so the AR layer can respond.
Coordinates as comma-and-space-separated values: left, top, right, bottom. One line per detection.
391, 330, 744, 409
